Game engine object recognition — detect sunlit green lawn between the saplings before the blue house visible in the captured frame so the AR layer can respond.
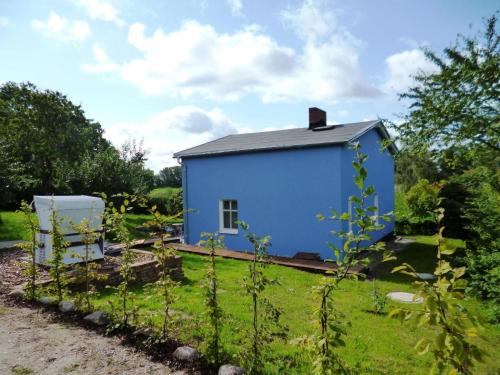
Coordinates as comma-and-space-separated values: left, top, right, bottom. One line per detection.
91, 236, 500, 374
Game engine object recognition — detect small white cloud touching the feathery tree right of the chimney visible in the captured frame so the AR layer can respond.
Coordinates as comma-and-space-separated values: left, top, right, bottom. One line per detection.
383, 49, 437, 94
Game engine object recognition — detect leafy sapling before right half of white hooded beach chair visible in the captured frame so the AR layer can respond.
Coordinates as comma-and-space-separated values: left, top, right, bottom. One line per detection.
73, 218, 106, 312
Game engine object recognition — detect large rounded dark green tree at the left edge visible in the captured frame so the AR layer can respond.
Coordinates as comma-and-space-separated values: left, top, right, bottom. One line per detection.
0, 82, 109, 198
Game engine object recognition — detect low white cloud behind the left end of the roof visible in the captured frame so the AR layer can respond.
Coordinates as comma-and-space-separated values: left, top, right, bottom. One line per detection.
104, 106, 238, 171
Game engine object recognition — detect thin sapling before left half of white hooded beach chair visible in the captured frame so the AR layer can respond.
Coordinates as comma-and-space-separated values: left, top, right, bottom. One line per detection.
48, 209, 69, 302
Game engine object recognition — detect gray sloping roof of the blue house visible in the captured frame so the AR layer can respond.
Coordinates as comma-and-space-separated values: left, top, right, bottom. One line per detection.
174, 120, 389, 158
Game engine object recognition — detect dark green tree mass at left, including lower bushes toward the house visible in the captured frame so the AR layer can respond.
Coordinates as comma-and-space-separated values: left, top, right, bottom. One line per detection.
0, 82, 154, 208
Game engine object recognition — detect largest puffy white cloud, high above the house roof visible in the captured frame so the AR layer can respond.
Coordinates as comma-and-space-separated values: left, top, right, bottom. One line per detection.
86, 2, 381, 102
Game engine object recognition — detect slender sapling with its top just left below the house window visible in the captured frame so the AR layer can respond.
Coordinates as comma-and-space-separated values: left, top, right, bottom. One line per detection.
200, 233, 224, 366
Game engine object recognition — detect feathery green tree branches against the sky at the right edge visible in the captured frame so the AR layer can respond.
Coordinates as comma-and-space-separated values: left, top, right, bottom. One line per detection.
398, 14, 500, 154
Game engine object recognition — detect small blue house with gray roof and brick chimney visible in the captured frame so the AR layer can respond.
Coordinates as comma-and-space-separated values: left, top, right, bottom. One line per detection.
174, 108, 395, 258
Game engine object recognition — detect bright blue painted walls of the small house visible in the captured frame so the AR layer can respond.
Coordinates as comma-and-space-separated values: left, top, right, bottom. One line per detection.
183, 131, 394, 258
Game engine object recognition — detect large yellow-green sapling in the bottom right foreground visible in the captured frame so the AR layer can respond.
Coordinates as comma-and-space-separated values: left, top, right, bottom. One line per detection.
389, 208, 484, 374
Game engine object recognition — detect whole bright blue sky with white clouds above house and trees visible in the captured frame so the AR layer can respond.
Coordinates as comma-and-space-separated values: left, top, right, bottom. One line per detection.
0, 0, 498, 171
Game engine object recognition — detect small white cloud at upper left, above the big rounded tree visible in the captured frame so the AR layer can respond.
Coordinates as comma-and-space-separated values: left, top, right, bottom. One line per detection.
32, 12, 91, 42
